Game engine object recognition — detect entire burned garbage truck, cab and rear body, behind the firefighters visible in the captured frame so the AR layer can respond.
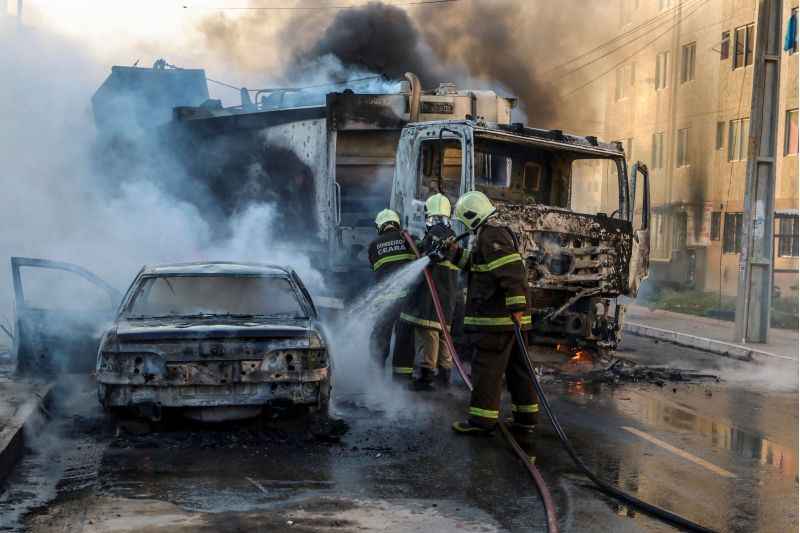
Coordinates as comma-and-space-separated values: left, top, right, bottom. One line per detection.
93, 63, 649, 352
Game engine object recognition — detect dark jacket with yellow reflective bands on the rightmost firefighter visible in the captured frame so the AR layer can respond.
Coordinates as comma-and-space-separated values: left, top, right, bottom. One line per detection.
453, 223, 531, 331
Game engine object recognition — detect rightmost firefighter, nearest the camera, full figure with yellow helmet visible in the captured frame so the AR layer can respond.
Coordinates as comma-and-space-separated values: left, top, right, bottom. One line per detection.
451, 191, 539, 434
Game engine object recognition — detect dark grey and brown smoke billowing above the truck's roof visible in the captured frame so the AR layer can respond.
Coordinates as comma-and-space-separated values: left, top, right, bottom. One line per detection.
199, 0, 617, 125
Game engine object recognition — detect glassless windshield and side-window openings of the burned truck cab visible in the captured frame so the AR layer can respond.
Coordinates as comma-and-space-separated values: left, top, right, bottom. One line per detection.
415, 128, 630, 219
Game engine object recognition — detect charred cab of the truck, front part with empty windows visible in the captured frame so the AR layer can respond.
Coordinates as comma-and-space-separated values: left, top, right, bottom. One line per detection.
391, 120, 650, 353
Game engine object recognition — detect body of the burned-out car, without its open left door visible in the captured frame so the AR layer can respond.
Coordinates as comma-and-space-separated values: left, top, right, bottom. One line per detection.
96, 262, 331, 421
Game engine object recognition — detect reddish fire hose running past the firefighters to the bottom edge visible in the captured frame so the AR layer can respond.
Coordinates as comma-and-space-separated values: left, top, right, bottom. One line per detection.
403, 231, 558, 533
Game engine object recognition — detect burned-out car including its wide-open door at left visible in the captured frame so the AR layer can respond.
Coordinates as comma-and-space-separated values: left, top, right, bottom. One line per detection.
11, 257, 331, 420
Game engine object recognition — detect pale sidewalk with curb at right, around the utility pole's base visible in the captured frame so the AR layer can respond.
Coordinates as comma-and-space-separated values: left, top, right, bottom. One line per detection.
625, 304, 798, 362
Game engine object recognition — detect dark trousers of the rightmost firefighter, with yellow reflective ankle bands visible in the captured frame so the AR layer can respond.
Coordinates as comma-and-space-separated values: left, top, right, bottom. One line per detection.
469, 331, 539, 427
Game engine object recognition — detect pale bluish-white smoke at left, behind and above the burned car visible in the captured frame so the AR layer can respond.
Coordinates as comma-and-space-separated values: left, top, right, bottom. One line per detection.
0, 25, 322, 328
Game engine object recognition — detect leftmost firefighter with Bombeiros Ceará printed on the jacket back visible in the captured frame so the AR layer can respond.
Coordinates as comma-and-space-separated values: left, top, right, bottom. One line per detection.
369, 209, 416, 379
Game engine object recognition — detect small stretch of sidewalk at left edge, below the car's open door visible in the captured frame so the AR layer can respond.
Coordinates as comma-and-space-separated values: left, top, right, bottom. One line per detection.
0, 359, 52, 482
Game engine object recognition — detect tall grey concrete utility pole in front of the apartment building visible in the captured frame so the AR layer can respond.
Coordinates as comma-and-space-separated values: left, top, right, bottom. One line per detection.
734, 0, 783, 342
